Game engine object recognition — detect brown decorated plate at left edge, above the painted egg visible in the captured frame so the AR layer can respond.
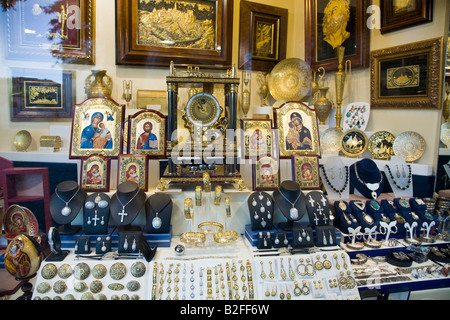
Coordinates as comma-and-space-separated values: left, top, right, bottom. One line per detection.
3, 204, 39, 239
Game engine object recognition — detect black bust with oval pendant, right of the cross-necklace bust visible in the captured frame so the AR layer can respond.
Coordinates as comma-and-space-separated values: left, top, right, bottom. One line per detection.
145, 193, 173, 234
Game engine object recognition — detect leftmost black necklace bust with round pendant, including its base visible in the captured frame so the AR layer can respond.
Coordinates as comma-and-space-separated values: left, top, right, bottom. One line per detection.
50, 181, 86, 235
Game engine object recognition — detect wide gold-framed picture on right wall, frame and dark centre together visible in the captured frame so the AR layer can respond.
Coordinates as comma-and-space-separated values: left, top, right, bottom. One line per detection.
370, 38, 445, 109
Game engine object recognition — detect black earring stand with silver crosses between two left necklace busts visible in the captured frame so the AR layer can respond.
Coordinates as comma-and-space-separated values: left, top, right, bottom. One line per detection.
83, 193, 111, 235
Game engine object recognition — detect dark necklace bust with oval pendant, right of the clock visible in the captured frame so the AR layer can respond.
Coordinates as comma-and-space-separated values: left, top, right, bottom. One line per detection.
273, 180, 306, 230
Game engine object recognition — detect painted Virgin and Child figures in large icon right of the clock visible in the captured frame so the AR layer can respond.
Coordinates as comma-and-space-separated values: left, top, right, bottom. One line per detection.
286, 112, 313, 150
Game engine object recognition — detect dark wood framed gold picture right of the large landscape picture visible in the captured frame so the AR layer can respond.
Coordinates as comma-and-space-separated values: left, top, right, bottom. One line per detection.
239, 1, 288, 72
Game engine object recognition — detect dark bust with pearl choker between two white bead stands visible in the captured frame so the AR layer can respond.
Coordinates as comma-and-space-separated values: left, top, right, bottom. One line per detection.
350, 159, 384, 199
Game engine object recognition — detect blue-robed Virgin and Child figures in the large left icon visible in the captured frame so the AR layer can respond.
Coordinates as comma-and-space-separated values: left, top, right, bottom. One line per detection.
80, 112, 113, 149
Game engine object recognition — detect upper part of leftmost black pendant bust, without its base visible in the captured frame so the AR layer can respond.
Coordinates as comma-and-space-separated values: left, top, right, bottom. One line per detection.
50, 181, 86, 229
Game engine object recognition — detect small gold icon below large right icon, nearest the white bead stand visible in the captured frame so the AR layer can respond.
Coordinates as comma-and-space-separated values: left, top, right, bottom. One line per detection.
291, 156, 320, 190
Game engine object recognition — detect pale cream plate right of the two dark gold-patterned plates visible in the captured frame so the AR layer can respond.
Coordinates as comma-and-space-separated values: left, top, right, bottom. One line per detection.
393, 131, 426, 162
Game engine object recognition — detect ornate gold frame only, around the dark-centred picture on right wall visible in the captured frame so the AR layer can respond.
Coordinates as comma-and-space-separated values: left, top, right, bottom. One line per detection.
370, 37, 445, 109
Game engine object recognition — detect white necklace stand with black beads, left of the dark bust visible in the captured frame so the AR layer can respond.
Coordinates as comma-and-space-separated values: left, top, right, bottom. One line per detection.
320, 157, 350, 201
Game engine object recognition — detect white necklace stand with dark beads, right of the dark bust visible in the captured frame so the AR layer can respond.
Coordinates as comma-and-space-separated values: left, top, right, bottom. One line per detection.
384, 156, 413, 198
